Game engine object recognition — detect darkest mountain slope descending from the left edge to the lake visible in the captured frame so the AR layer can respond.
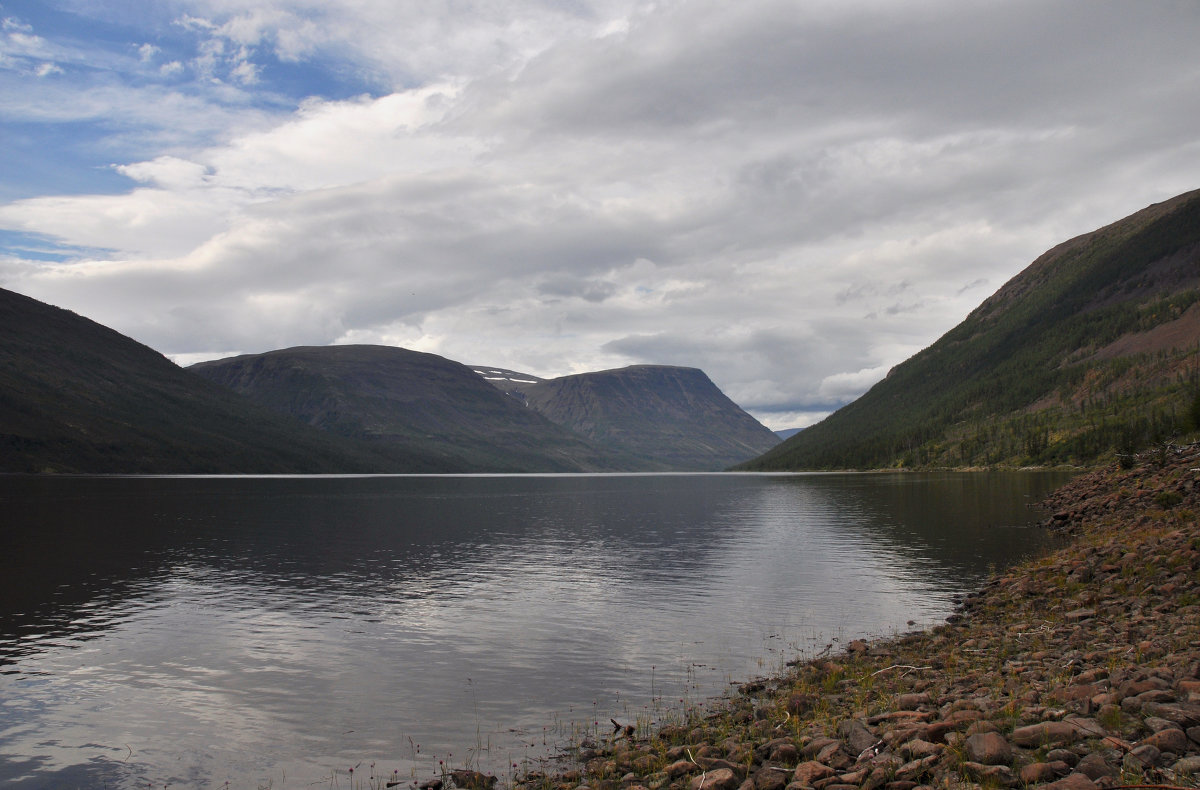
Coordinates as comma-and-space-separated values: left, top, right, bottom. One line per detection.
0, 289, 403, 473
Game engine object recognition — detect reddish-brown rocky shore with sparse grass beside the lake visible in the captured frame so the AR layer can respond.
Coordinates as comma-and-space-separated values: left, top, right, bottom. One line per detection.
501, 445, 1200, 790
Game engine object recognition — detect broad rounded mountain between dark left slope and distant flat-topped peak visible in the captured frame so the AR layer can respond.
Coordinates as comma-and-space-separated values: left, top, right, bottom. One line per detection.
188, 346, 654, 472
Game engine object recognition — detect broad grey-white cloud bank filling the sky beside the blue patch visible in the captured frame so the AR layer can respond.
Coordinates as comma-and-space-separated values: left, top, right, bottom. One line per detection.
5, 0, 1200, 429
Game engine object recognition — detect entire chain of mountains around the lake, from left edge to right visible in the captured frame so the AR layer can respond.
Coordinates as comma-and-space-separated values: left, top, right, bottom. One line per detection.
0, 191, 1200, 473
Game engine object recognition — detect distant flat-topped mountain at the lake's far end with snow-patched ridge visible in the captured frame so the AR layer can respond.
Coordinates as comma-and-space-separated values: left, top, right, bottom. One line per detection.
475, 365, 779, 471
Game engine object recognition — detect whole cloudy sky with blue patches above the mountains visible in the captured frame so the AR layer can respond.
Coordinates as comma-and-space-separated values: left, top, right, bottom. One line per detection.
0, 0, 1200, 429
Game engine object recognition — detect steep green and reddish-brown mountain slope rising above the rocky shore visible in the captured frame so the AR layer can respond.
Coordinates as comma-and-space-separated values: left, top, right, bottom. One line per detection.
740, 190, 1200, 469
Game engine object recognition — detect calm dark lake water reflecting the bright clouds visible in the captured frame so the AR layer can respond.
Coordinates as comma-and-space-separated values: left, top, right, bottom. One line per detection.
0, 473, 1066, 788
